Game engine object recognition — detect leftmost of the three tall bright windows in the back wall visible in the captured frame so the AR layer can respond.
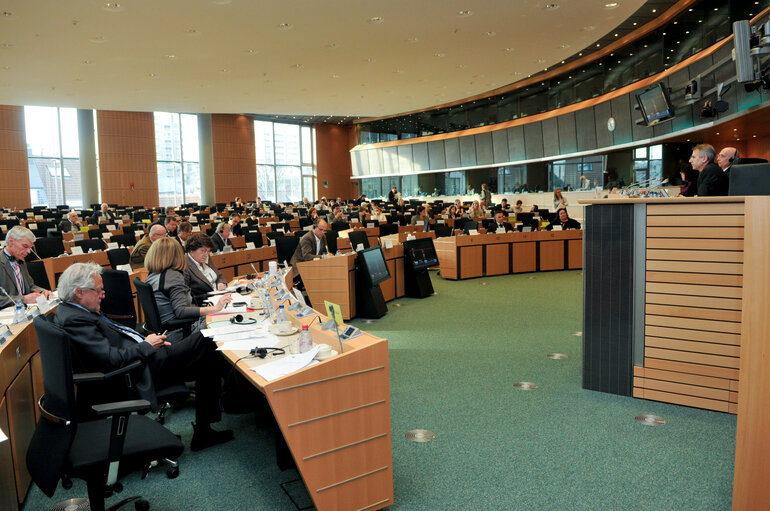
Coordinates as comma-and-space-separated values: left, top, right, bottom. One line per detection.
23, 106, 83, 208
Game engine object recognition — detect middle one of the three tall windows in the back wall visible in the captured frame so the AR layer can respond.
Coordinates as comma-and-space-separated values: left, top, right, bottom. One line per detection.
155, 112, 201, 206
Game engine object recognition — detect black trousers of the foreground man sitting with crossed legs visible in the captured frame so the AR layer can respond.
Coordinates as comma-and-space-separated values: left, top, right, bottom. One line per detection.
148, 332, 225, 425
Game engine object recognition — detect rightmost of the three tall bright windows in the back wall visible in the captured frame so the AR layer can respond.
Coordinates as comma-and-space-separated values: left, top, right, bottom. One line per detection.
254, 121, 316, 202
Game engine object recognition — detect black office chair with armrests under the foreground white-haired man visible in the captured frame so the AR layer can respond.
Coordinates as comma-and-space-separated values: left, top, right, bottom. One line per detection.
26, 315, 184, 511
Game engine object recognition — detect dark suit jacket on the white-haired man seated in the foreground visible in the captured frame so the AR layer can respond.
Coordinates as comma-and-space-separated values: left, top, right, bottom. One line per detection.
54, 302, 157, 407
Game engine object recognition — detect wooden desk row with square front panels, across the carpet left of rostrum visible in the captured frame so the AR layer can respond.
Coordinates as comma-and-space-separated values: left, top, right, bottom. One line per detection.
434, 230, 583, 280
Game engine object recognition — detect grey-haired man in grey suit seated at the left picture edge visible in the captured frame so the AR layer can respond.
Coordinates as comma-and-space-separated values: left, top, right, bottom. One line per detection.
0, 225, 52, 309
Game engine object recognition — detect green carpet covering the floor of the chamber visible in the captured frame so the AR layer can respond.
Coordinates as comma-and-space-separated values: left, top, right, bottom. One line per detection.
23, 271, 735, 511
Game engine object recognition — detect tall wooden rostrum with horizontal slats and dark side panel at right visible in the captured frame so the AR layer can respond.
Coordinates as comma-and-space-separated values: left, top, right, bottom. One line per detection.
581, 196, 770, 510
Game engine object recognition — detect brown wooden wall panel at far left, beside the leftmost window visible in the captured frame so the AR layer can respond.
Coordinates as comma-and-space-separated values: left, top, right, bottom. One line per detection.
0, 105, 32, 209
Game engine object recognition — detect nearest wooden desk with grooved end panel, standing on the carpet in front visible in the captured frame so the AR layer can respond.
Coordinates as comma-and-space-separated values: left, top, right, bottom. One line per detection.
223, 294, 393, 511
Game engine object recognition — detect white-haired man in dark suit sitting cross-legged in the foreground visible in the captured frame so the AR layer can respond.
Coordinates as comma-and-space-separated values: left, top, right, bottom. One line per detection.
55, 263, 233, 451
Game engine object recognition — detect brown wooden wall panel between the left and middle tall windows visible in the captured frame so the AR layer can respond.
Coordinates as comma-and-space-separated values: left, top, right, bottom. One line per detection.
96, 110, 159, 207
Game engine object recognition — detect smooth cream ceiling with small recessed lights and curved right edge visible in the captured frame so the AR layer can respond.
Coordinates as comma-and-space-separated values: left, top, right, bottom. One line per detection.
0, 0, 644, 116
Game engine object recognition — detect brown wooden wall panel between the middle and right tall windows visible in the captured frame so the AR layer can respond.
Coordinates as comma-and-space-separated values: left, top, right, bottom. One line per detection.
211, 114, 258, 202
